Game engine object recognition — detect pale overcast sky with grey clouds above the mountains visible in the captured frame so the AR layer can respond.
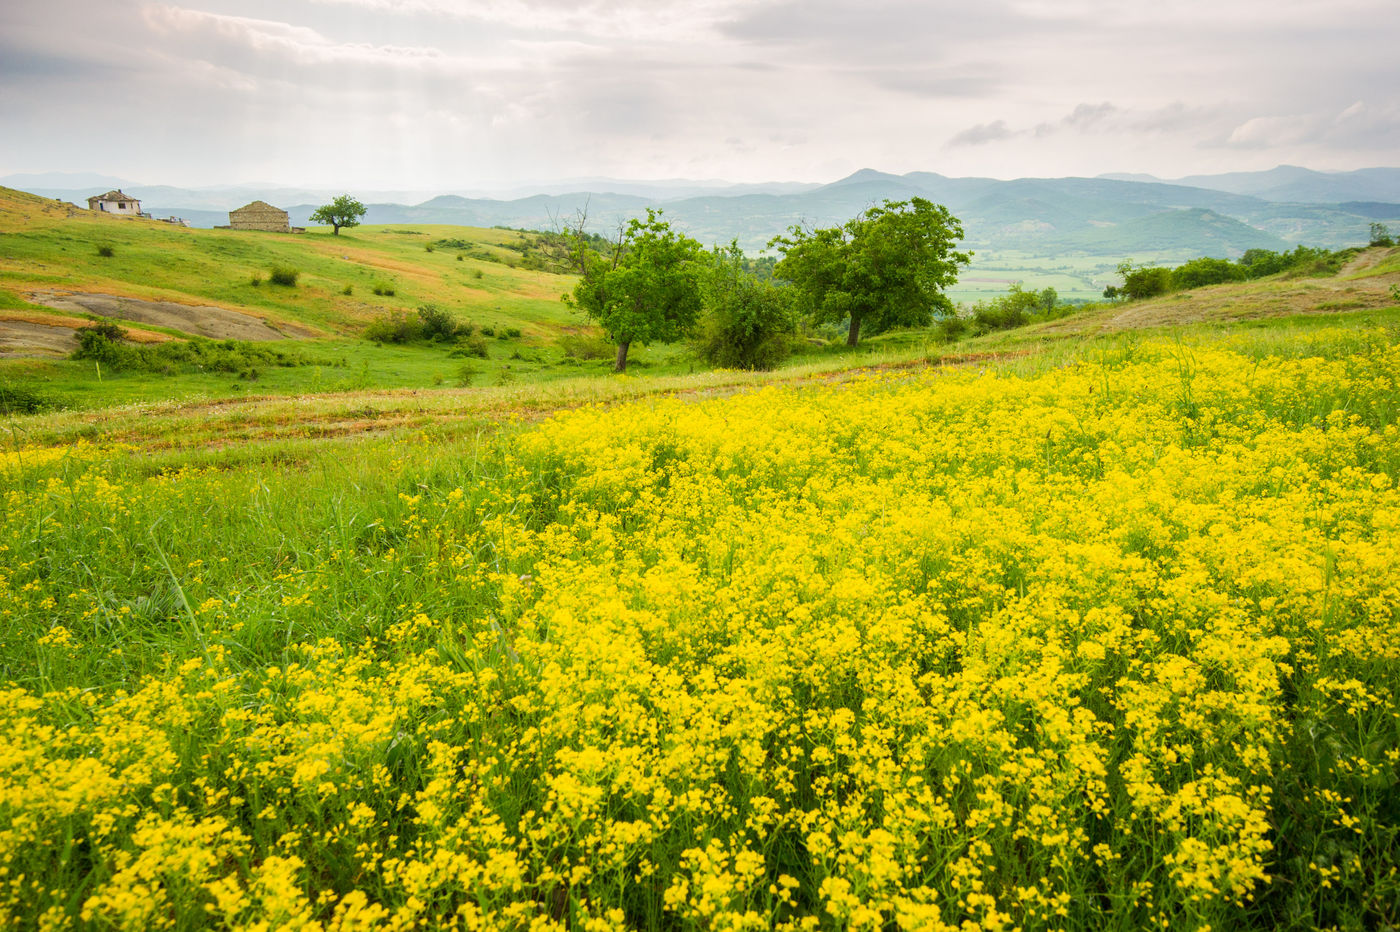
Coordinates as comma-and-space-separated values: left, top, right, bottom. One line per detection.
0, 0, 1400, 190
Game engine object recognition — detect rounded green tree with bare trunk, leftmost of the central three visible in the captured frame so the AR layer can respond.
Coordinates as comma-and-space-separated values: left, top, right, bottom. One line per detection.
566, 207, 703, 372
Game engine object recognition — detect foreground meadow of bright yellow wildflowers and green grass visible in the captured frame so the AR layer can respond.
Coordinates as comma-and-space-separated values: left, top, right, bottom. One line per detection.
0, 329, 1400, 931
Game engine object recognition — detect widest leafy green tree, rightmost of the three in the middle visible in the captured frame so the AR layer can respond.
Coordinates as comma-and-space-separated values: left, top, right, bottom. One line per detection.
769, 197, 972, 346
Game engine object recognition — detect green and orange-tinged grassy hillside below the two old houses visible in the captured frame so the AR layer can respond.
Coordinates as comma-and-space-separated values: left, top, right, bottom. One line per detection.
0, 189, 711, 406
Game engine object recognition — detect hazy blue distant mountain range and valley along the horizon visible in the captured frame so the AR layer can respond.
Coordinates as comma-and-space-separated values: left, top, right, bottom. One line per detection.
8, 165, 1400, 260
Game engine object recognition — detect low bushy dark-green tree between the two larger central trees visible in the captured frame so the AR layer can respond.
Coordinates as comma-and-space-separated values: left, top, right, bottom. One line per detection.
694, 241, 794, 369
